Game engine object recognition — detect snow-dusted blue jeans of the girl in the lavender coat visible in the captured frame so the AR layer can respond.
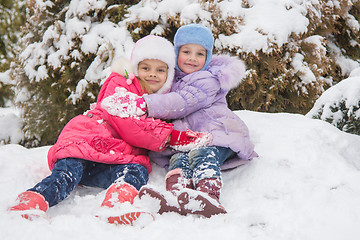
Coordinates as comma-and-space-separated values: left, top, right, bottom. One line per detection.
169, 146, 236, 186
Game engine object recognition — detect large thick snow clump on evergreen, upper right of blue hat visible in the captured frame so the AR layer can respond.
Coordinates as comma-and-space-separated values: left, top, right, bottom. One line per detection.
219, 0, 309, 52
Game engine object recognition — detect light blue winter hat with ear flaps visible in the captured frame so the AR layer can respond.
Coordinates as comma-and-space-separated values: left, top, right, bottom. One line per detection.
174, 23, 214, 70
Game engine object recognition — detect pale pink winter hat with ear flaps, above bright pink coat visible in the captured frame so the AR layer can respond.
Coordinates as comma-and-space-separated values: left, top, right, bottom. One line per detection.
130, 35, 176, 93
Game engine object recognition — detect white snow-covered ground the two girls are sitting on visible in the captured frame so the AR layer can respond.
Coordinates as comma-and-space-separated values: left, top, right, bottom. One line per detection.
0, 109, 360, 240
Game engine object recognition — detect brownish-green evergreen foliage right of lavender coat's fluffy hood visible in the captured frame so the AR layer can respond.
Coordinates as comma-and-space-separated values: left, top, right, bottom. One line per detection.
227, 41, 323, 113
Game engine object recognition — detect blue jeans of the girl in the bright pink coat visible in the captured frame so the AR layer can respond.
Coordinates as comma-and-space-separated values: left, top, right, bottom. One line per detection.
28, 158, 149, 207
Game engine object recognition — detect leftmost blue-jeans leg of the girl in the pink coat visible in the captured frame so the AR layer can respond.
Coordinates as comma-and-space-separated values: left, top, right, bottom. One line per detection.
28, 158, 85, 207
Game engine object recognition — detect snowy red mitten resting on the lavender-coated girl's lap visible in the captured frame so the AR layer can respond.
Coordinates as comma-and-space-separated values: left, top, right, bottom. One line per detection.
169, 129, 212, 151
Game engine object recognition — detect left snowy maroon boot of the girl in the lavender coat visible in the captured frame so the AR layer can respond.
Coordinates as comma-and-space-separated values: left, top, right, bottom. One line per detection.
139, 168, 192, 215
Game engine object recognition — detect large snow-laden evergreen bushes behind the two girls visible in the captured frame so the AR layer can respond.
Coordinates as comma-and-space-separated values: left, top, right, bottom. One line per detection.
11, 0, 360, 145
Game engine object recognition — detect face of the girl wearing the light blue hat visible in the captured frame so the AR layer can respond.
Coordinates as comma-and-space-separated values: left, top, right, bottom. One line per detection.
177, 43, 206, 73
